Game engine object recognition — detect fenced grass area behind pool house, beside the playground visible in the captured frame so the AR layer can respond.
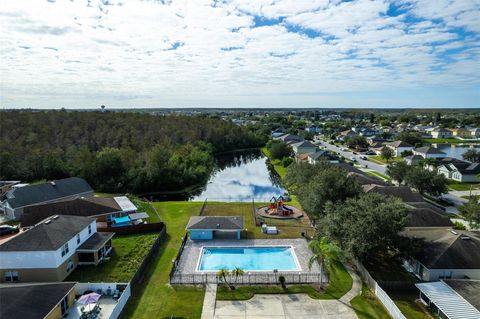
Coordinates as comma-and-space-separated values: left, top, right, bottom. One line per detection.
204, 202, 313, 239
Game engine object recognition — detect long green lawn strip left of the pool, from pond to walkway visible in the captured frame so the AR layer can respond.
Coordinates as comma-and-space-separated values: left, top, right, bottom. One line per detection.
122, 202, 204, 319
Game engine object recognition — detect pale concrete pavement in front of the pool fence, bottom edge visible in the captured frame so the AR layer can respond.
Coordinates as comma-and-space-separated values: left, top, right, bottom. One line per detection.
214, 294, 357, 319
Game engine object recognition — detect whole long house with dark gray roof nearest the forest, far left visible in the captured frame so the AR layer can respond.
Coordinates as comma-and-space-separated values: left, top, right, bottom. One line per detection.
0, 177, 93, 219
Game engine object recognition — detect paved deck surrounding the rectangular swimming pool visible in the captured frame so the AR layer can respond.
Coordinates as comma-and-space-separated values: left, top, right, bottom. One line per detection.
175, 238, 320, 274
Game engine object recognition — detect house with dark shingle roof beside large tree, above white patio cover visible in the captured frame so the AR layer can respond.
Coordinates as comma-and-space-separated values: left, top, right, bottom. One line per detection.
401, 227, 480, 281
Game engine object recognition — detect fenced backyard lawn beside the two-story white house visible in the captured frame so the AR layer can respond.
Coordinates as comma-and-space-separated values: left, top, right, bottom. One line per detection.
66, 233, 158, 282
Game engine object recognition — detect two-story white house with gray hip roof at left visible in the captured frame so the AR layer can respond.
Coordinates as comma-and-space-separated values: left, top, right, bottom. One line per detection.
0, 215, 114, 282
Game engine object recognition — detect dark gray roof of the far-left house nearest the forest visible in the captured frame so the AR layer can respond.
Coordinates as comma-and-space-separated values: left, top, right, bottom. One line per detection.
7, 177, 93, 208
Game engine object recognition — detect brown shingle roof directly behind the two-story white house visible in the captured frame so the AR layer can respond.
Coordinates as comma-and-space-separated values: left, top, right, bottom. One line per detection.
20, 197, 122, 227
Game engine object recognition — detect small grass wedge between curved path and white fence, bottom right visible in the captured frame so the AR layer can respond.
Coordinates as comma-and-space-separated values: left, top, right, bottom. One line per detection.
350, 285, 392, 319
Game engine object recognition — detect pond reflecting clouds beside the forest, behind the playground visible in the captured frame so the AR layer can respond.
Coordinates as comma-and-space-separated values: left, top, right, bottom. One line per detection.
190, 150, 285, 202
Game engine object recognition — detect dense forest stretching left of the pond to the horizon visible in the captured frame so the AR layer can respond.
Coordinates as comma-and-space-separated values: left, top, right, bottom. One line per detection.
0, 111, 267, 193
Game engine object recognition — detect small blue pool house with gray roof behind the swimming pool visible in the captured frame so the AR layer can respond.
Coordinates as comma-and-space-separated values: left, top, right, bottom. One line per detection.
186, 216, 244, 240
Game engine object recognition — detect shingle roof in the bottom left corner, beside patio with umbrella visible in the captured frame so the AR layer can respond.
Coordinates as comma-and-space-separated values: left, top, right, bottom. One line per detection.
0, 282, 76, 319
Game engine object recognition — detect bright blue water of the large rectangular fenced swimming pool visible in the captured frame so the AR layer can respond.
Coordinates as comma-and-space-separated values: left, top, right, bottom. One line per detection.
198, 247, 299, 271
